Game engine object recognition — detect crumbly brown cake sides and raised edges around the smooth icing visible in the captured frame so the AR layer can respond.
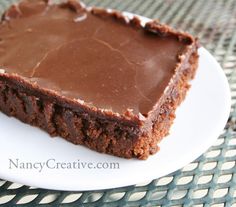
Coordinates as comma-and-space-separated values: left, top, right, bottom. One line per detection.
0, 1, 198, 160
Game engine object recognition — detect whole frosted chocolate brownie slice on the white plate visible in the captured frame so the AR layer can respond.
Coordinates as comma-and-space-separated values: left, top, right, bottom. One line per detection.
0, 0, 198, 159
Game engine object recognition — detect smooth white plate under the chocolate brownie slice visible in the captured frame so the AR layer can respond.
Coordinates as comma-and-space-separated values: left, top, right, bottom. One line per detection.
0, 13, 230, 191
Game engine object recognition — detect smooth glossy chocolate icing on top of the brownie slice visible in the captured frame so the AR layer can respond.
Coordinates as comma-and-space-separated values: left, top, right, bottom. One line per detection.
0, 0, 186, 115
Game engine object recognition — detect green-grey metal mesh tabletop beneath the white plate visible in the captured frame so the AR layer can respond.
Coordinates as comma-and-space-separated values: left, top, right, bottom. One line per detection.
0, 0, 236, 207
